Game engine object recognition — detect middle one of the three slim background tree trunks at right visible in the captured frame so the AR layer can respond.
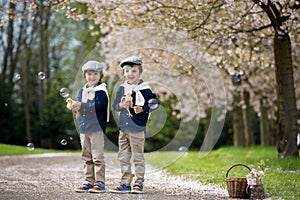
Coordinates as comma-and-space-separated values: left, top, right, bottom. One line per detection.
242, 91, 255, 146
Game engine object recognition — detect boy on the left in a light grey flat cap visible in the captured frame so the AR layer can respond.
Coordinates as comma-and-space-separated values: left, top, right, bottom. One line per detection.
71, 61, 109, 193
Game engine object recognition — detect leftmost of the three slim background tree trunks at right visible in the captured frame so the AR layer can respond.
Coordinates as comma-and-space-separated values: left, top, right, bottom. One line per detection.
232, 92, 245, 147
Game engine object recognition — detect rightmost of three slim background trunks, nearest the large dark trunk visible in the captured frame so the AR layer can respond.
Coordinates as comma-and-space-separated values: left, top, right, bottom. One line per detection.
259, 99, 272, 146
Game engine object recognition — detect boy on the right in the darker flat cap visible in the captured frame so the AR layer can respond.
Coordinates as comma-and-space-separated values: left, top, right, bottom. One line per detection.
109, 56, 156, 193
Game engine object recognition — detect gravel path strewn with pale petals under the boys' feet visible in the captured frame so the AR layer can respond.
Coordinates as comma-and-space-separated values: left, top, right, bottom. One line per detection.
0, 153, 229, 200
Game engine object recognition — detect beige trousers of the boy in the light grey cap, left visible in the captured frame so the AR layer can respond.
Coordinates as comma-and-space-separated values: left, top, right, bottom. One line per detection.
80, 131, 105, 186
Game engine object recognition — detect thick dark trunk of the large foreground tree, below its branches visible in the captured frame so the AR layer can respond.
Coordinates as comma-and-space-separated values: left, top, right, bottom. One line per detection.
274, 33, 298, 158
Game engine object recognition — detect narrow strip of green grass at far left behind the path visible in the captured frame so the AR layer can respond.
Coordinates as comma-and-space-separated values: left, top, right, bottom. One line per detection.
0, 143, 69, 156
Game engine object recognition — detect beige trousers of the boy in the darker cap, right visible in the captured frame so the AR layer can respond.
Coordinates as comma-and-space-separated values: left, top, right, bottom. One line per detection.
118, 131, 145, 185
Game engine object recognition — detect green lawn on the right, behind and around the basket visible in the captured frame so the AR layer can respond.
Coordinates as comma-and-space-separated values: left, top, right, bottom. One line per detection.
146, 146, 300, 200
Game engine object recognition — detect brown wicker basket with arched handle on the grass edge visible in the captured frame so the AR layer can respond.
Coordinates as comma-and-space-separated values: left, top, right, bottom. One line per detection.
225, 164, 251, 199
